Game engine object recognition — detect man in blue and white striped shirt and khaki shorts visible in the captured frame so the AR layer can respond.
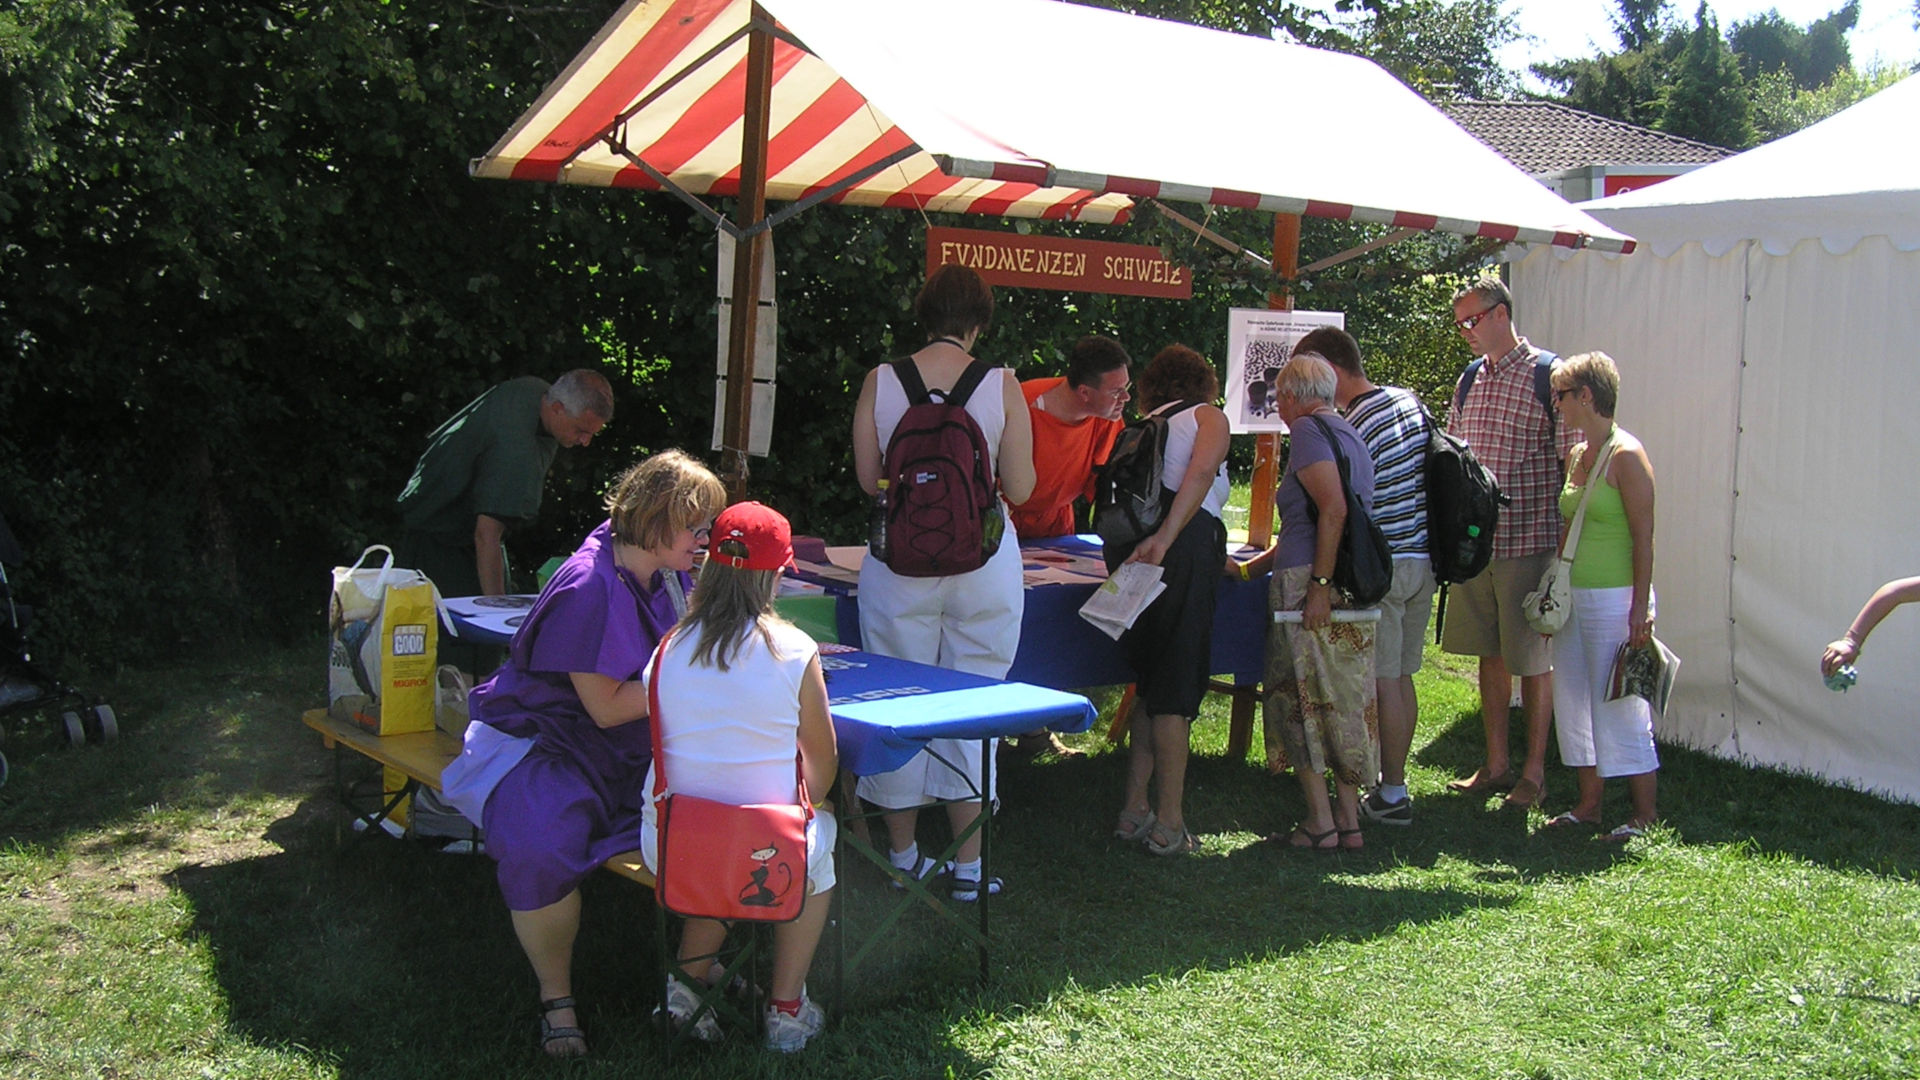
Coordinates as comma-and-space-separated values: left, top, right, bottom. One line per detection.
1294, 327, 1434, 824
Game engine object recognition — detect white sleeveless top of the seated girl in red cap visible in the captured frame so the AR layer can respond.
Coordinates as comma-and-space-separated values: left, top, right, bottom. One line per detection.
647, 626, 826, 807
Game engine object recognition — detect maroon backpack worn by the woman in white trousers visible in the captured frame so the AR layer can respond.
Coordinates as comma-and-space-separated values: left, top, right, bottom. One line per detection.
881, 359, 1006, 578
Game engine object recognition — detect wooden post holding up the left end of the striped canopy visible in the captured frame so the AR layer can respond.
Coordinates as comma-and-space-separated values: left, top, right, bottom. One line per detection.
720, 4, 774, 502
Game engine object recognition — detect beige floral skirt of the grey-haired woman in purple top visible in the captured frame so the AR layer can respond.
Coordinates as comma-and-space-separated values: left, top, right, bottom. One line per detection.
1261, 567, 1380, 786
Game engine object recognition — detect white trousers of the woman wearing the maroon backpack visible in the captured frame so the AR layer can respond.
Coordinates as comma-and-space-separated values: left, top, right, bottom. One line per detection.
858, 509, 1025, 809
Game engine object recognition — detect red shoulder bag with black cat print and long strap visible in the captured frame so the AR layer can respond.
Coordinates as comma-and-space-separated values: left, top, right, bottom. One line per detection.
647, 632, 814, 922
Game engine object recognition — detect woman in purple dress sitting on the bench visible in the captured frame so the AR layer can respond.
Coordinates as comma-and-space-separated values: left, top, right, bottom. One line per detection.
442, 450, 726, 1057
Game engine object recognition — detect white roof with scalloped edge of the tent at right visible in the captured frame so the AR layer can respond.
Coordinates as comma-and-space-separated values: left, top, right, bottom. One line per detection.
1580, 77, 1920, 258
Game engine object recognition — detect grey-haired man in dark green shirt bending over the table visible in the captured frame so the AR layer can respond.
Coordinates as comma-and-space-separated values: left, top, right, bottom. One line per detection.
394, 369, 612, 596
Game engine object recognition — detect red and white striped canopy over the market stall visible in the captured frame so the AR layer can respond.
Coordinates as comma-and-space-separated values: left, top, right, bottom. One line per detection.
472, 0, 1632, 252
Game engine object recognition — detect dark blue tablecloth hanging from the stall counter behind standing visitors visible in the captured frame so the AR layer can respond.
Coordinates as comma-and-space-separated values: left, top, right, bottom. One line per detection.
814, 536, 1267, 690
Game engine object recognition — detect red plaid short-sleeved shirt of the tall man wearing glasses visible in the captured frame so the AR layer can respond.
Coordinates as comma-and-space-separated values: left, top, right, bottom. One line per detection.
1446, 338, 1580, 559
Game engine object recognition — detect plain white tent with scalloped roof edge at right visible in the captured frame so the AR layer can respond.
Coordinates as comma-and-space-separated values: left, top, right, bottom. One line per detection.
1511, 79, 1920, 799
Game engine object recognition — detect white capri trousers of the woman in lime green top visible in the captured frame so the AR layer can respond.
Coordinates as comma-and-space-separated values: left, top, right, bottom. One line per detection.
1553, 586, 1661, 778
